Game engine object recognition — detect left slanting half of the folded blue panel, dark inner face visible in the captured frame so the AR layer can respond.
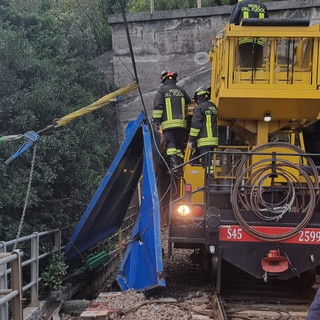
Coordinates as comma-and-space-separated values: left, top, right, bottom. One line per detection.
65, 113, 145, 259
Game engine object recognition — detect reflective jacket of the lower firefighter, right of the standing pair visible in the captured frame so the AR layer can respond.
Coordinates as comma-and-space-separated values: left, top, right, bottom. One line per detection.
189, 98, 218, 148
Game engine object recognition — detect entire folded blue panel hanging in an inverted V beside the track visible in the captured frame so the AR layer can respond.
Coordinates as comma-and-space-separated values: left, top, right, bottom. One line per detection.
66, 113, 165, 290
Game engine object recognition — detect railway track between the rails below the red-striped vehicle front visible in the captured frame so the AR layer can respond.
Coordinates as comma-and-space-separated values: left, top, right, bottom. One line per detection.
212, 264, 315, 320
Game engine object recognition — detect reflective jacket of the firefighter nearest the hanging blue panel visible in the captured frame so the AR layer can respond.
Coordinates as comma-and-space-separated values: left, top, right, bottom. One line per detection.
153, 79, 191, 130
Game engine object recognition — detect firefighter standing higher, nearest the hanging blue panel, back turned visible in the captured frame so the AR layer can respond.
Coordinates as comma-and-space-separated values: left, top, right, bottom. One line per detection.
153, 71, 191, 169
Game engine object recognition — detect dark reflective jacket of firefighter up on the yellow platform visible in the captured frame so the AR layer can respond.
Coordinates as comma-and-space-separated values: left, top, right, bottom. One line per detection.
230, 0, 269, 46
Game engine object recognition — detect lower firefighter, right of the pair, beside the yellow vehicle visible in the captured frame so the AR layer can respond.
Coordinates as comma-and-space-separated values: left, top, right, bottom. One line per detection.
188, 87, 218, 171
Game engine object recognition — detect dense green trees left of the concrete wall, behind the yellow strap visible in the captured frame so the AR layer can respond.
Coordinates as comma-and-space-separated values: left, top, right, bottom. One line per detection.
0, 0, 118, 240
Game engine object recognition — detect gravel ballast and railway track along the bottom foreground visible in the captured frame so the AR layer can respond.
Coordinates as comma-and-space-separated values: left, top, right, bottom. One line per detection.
62, 232, 315, 320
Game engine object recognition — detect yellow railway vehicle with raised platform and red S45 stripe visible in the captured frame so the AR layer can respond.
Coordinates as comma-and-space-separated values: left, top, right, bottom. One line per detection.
168, 19, 320, 291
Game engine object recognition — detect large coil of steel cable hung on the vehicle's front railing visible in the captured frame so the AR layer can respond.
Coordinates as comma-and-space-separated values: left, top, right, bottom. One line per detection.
231, 142, 319, 241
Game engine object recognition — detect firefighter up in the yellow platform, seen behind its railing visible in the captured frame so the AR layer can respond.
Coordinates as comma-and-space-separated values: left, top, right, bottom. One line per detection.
230, 0, 269, 69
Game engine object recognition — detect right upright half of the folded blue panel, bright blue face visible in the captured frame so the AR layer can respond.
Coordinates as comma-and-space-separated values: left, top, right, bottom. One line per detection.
117, 125, 165, 290
